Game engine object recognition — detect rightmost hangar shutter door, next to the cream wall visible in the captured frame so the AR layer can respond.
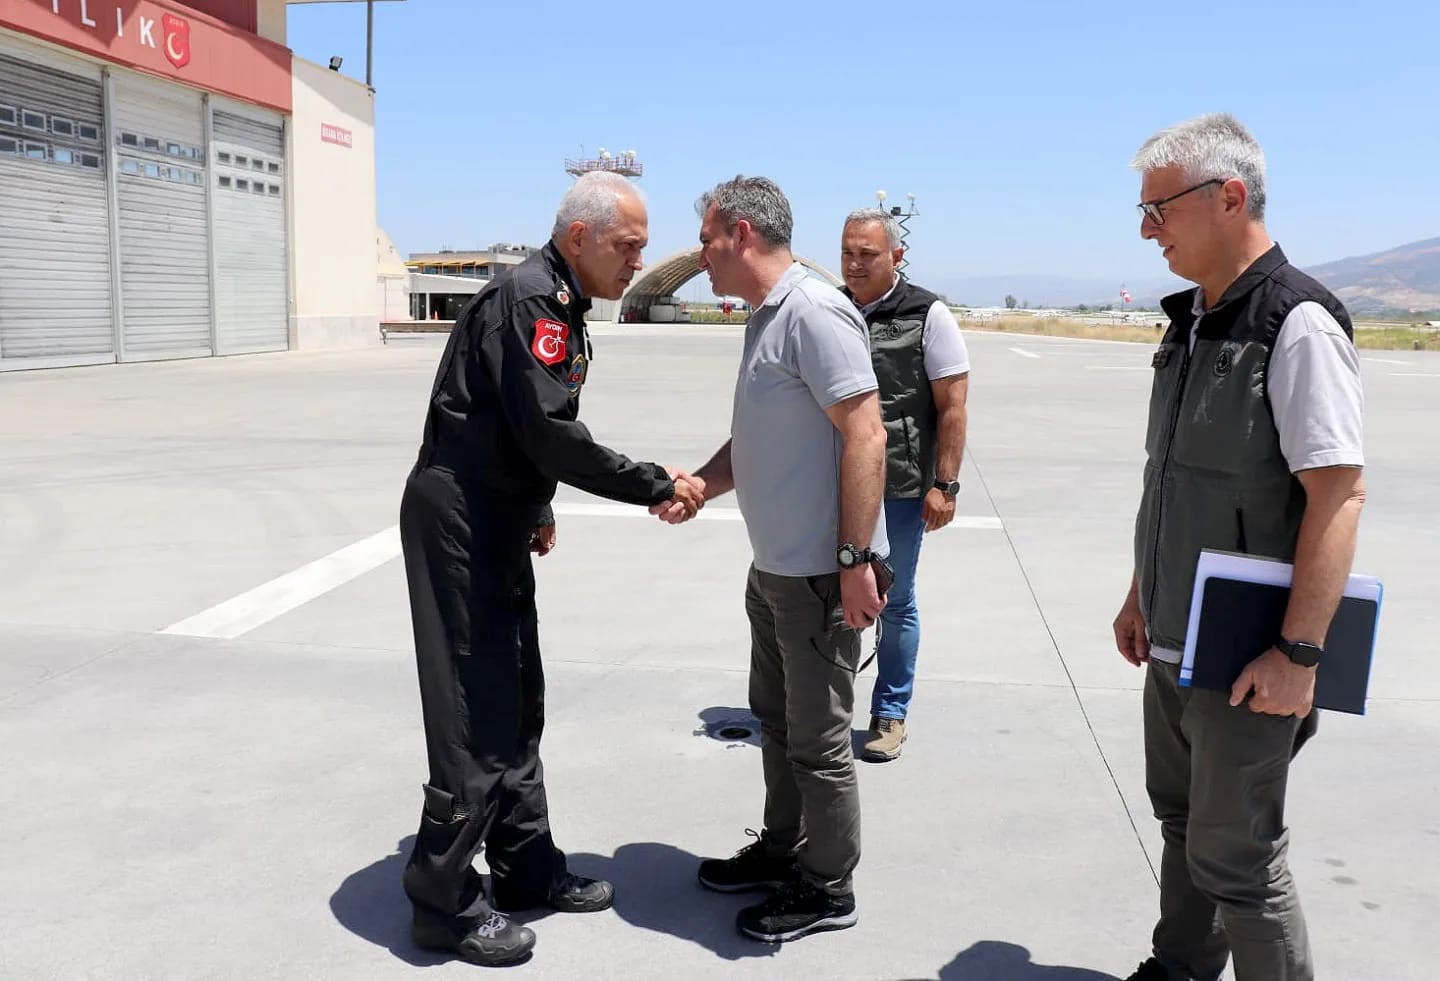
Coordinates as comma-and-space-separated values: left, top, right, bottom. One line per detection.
210, 109, 289, 354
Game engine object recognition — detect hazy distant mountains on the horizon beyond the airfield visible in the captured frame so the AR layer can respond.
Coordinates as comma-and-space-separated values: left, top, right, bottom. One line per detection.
922, 238, 1440, 313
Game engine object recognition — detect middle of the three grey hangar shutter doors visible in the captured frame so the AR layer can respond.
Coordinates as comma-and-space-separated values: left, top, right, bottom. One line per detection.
111, 72, 213, 362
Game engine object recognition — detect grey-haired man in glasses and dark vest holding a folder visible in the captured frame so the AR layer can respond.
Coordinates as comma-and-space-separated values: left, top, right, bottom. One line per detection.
1115, 115, 1365, 981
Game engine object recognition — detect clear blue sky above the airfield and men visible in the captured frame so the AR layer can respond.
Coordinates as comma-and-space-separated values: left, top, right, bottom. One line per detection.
289, 0, 1440, 297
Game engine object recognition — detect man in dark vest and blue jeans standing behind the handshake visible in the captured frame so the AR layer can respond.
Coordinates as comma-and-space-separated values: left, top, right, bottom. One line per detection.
840, 209, 971, 762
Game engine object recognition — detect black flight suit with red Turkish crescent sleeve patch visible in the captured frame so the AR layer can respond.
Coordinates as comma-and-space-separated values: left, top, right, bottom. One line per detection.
400, 243, 674, 925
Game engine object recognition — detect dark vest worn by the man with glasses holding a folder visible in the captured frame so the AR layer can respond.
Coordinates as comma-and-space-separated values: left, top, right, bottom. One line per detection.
1135, 245, 1354, 651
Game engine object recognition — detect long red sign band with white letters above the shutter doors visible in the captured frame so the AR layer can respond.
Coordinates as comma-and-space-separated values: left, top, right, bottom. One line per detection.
0, 0, 291, 112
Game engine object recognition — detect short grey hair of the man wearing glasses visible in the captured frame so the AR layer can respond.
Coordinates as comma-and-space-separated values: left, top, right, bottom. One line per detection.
1130, 112, 1264, 222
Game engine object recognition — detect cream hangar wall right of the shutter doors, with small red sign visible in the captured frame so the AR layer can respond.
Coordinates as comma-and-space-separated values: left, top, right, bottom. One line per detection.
289, 58, 380, 350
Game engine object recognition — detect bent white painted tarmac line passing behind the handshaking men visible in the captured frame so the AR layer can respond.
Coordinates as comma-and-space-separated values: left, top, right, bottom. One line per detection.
160, 503, 1004, 641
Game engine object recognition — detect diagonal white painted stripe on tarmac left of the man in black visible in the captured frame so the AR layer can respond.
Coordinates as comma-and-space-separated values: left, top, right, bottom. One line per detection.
160, 526, 400, 640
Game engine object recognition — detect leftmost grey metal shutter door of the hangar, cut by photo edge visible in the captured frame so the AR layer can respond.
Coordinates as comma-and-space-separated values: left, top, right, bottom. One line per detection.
0, 39, 115, 367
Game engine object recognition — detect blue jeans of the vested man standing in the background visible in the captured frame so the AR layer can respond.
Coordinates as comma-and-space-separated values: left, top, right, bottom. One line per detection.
870, 497, 924, 719
